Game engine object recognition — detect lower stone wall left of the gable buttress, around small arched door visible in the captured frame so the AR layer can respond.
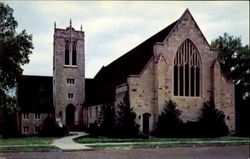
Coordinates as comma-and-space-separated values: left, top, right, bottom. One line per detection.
128, 59, 156, 131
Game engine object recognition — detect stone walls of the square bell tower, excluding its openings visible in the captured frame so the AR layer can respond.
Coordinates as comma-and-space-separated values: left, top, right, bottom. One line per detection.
53, 27, 85, 125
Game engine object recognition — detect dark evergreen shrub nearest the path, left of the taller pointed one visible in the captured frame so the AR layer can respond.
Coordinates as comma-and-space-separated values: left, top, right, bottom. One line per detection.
97, 104, 115, 136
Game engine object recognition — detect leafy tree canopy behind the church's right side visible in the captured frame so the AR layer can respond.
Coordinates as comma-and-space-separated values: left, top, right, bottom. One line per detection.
211, 33, 250, 100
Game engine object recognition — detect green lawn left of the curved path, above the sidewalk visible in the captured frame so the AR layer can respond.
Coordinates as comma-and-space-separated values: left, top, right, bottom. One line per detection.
0, 136, 56, 145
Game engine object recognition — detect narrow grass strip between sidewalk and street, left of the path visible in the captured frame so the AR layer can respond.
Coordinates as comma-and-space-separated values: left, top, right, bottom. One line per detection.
0, 146, 59, 151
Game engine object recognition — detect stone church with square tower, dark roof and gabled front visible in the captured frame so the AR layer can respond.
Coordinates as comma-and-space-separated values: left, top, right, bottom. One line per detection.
15, 9, 235, 133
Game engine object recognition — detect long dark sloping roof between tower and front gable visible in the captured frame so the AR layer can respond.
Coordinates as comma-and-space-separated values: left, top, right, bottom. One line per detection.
86, 20, 178, 106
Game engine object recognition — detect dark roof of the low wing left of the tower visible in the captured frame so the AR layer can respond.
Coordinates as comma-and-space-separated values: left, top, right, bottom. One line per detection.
17, 75, 54, 113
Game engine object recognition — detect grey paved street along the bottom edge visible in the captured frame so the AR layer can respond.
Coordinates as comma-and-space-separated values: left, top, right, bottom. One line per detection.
0, 145, 249, 159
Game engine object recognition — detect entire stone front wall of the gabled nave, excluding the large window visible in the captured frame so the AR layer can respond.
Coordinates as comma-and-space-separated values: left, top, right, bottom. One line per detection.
123, 12, 235, 131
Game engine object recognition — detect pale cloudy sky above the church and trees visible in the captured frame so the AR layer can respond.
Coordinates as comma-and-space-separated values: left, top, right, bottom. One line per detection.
5, 1, 249, 78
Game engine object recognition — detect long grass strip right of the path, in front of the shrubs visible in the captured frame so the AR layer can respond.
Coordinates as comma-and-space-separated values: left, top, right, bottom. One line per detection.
74, 136, 249, 143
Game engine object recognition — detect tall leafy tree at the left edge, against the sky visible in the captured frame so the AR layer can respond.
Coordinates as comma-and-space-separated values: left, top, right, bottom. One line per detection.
0, 2, 33, 135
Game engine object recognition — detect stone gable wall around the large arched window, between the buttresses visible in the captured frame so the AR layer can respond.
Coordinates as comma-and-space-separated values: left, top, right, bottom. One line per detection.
155, 11, 214, 121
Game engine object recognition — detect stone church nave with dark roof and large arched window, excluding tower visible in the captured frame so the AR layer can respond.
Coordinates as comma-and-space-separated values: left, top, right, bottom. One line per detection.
84, 9, 235, 133
